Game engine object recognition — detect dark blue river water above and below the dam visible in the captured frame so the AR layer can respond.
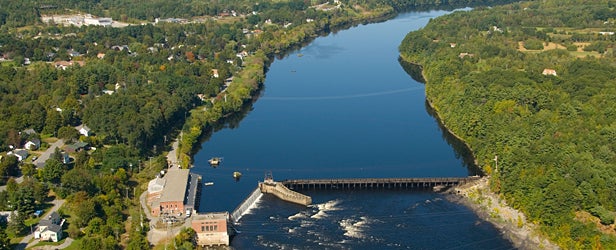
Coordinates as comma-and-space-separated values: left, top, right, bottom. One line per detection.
192, 11, 512, 249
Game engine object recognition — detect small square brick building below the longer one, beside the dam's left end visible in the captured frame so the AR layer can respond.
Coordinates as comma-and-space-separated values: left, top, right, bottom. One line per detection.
191, 212, 229, 247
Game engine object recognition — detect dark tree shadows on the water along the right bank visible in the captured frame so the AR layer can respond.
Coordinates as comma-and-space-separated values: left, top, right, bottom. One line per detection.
398, 58, 483, 175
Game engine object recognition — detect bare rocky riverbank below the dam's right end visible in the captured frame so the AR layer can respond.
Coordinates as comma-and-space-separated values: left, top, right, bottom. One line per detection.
448, 176, 560, 249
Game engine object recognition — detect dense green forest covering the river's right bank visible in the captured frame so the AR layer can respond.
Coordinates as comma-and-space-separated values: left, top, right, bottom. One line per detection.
399, 0, 616, 249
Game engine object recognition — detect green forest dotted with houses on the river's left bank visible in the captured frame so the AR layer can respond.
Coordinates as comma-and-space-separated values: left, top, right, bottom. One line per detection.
0, 0, 516, 250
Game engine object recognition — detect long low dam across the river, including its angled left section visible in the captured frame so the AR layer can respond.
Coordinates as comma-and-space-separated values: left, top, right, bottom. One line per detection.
230, 175, 481, 223
